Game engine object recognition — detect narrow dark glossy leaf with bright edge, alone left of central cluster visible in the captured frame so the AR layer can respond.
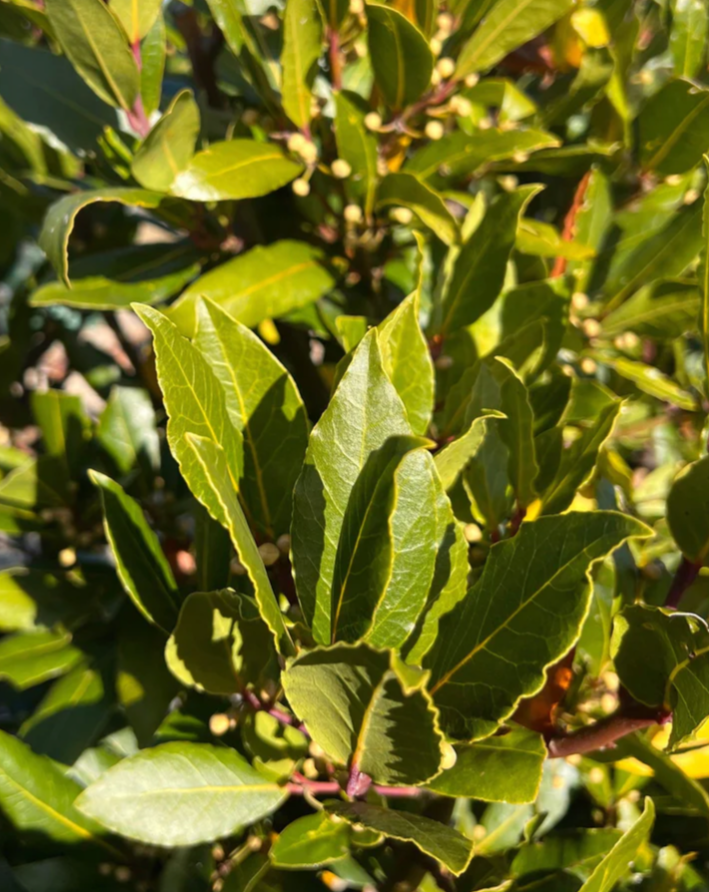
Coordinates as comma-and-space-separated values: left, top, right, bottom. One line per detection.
89, 471, 178, 633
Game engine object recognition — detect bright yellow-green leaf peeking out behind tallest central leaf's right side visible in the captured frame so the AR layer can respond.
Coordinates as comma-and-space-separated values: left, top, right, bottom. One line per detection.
378, 292, 434, 436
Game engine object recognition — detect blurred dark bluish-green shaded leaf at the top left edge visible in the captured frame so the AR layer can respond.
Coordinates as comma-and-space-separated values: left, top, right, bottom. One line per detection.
0, 40, 118, 152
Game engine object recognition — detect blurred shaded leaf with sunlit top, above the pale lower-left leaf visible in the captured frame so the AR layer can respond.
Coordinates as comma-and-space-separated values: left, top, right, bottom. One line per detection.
20, 665, 114, 765
